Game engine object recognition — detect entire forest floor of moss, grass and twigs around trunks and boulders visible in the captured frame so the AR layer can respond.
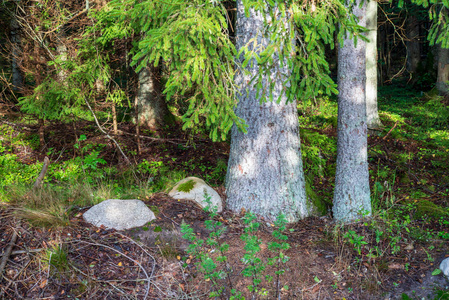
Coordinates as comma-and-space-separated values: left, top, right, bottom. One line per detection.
0, 85, 449, 299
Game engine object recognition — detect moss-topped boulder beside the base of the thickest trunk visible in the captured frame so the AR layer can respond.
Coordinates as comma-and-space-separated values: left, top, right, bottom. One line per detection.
168, 177, 223, 212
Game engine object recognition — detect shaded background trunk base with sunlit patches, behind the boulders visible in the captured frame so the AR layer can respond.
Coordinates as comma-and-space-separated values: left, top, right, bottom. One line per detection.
137, 67, 173, 129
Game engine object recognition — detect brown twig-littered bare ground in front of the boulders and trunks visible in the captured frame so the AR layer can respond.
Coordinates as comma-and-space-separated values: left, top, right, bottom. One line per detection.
0, 193, 449, 299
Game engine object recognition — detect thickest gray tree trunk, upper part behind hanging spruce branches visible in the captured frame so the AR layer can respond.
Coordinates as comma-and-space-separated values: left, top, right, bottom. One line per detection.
226, 0, 309, 222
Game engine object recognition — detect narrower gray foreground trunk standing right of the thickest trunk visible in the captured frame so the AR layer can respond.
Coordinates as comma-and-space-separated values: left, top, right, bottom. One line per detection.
333, 0, 371, 222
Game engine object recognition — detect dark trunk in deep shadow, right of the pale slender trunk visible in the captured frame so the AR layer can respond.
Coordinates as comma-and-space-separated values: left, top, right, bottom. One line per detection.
406, 14, 421, 76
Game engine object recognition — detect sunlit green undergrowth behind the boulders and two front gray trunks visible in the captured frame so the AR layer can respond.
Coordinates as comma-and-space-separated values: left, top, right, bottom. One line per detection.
0, 85, 449, 232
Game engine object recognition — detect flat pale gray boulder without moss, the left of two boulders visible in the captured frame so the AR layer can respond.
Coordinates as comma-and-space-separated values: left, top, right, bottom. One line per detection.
83, 199, 156, 230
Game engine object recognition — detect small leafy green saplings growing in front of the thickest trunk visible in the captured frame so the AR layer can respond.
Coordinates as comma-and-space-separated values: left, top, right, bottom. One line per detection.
181, 195, 290, 300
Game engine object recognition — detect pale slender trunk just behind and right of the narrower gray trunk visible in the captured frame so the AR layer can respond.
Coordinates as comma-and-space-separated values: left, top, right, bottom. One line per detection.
366, 0, 382, 129
